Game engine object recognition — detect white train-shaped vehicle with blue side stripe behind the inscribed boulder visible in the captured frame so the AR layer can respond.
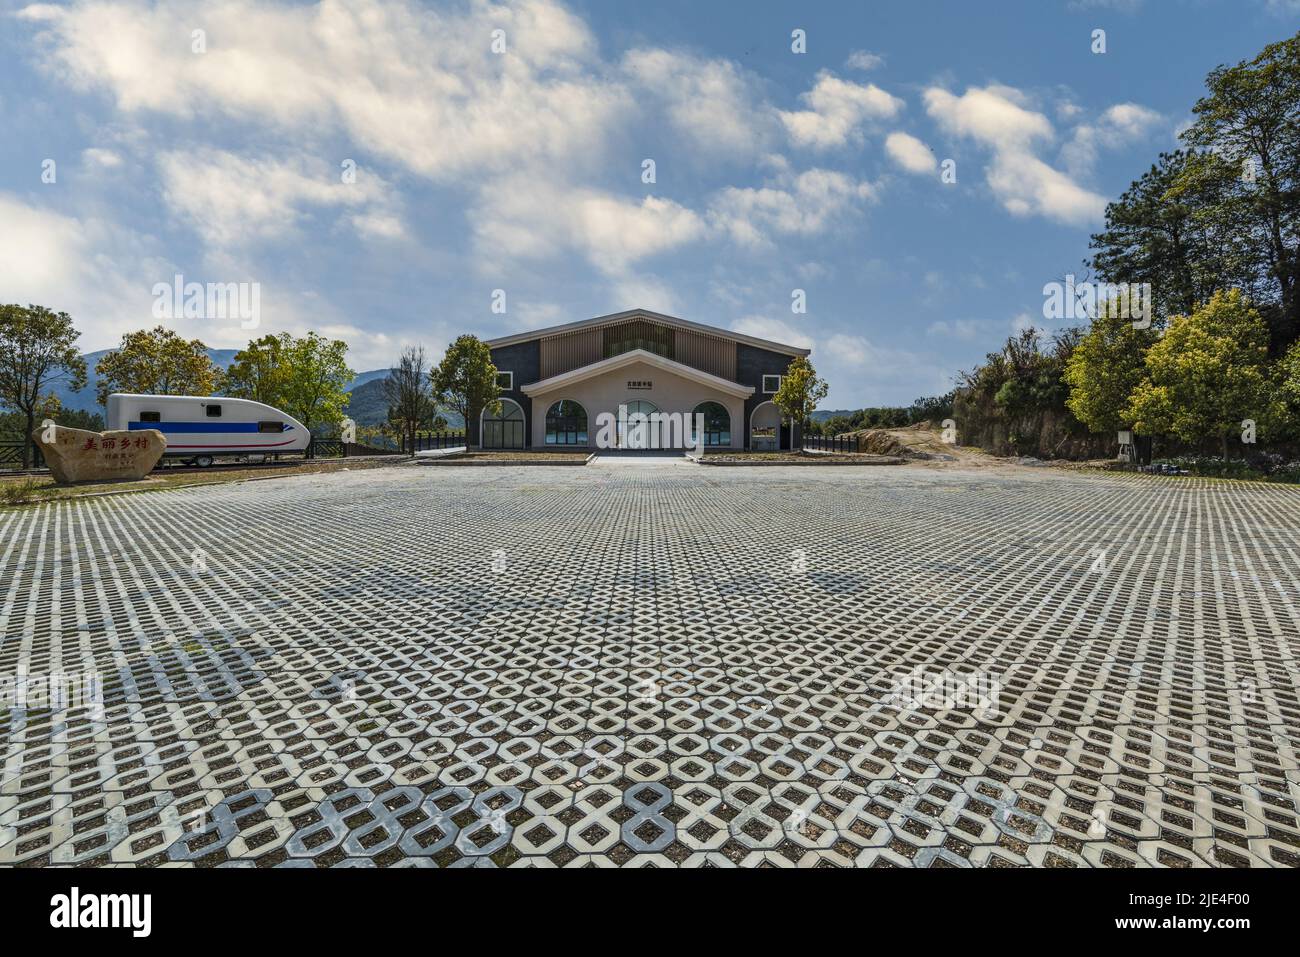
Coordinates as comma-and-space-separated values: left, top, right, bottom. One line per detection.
108, 393, 312, 465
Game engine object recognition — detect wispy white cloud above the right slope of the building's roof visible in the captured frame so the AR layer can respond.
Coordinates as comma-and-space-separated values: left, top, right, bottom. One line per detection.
709, 169, 875, 247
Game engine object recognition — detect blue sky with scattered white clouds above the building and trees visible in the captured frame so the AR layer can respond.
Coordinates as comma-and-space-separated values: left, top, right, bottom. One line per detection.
0, 0, 1300, 408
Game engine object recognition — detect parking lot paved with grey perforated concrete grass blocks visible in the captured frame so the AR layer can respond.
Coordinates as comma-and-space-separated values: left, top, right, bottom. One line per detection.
0, 465, 1300, 867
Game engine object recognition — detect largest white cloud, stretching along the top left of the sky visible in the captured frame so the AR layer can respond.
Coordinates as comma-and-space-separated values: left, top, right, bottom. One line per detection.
18, 0, 631, 179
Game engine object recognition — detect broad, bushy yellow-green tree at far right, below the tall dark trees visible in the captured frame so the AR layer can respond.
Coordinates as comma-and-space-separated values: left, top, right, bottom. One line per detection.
1125, 290, 1281, 460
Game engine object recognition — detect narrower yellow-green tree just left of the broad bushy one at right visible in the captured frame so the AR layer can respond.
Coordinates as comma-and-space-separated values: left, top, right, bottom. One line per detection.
1063, 302, 1158, 432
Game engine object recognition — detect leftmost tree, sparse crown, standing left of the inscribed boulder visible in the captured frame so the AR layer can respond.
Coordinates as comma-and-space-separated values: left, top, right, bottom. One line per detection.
0, 304, 86, 468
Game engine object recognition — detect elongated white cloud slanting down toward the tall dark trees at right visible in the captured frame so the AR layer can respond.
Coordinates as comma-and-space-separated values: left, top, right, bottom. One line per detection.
924, 85, 1106, 225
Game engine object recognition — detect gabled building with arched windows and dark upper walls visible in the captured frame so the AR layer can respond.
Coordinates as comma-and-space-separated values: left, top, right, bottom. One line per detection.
465, 309, 809, 450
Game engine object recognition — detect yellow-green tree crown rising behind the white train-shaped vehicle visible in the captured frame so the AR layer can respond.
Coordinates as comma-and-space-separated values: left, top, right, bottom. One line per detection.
95, 325, 222, 406
